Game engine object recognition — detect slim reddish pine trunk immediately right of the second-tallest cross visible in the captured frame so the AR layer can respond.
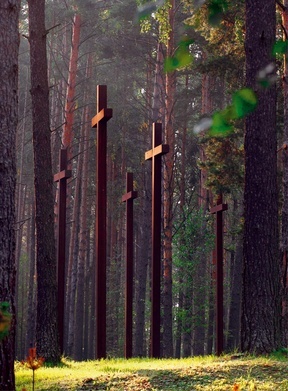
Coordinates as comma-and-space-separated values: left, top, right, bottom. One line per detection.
163, 0, 176, 357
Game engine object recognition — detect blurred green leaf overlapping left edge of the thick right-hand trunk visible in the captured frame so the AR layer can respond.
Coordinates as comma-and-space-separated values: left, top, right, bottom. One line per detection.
232, 88, 257, 118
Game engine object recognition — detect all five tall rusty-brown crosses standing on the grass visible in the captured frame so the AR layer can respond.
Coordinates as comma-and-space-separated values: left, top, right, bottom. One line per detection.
54, 85, 227, 359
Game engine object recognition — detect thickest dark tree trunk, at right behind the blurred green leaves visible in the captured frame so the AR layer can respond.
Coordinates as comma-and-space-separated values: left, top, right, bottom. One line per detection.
241, 0, 281, 354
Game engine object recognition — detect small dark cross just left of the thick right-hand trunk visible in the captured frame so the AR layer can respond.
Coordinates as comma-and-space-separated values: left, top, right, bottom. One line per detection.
210, 194, 228, 356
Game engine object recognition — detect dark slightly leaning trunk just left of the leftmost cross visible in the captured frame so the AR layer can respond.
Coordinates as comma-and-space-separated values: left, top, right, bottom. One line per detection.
28, 0, 60, 362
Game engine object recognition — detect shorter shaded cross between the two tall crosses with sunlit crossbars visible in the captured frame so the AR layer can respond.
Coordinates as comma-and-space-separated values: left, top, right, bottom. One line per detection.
122, 172, 138, 358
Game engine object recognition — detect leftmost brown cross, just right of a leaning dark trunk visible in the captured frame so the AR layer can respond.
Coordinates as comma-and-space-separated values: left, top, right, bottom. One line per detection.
54, 148, 71, 354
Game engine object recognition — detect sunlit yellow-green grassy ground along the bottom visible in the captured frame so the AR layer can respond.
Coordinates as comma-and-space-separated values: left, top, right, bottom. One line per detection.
16, 353, 288, 391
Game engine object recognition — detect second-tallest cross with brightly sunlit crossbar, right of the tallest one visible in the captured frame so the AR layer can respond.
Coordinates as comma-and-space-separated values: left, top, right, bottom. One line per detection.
145, 123, 169, 358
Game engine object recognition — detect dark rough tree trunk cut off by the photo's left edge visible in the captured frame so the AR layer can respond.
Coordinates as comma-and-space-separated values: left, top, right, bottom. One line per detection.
0, 0, 20, 391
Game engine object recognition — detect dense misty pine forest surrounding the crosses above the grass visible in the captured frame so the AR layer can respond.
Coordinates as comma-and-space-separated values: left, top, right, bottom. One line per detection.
0, 0, 288, 391
